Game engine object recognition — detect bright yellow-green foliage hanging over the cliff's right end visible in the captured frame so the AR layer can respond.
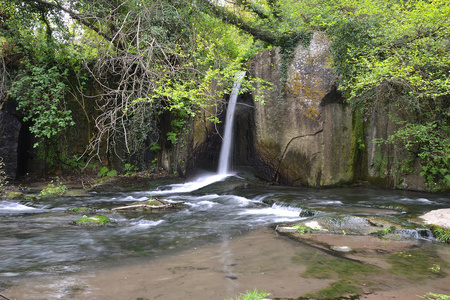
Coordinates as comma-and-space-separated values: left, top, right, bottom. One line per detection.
327, 0, 450, 190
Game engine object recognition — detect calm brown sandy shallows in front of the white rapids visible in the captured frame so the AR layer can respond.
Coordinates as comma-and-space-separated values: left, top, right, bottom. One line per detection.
1, 228, 450, 300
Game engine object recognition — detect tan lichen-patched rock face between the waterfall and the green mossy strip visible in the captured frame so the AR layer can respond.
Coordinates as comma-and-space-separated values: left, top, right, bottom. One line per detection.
252, 33, 355, 186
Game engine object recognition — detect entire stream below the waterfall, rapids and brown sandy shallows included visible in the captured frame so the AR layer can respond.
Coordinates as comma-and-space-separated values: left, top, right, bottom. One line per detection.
0, 173, 450, 300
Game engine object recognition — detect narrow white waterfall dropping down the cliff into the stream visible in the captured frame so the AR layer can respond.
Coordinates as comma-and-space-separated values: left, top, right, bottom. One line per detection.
217, 72, 245, 175
